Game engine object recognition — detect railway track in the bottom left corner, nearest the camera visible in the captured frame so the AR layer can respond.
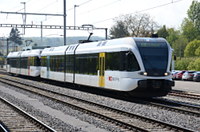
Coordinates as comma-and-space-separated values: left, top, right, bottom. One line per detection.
0, 97, 56, 132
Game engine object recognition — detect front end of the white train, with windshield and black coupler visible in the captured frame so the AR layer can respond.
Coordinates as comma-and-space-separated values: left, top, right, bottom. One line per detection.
128, 38, 174, 96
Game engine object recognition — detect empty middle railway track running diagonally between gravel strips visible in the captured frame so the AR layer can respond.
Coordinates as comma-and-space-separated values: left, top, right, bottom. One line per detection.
0, 77, 195, 131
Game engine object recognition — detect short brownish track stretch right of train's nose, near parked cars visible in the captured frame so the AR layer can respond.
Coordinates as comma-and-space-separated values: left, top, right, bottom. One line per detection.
168, 90, 200, 100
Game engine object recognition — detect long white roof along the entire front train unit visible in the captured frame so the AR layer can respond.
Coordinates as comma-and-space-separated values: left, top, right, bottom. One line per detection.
41, 37, 170, 56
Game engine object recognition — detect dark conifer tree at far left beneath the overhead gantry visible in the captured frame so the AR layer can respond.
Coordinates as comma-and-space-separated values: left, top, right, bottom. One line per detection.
9, 28, 22, 45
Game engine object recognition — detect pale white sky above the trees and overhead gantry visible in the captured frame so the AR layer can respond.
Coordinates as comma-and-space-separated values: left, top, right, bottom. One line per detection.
0, 0, 195, 37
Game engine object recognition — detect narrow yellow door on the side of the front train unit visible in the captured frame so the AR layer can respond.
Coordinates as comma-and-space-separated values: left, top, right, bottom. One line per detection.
99, 53, 105, 87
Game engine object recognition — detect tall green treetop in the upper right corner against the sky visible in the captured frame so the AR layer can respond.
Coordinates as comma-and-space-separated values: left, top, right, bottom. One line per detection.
187, 0, 200, 31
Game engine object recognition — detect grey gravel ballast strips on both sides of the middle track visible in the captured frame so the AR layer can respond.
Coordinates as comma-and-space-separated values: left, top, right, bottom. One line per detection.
0, 77, 200, 131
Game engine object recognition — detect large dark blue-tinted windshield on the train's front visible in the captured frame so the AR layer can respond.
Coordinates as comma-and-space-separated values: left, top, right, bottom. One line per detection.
136, 41, 168, 76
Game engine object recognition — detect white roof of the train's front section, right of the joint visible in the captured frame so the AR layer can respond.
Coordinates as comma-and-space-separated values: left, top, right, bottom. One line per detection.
76, 37, 169, 54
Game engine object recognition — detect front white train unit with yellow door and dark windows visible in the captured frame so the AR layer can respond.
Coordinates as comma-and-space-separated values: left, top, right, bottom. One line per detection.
8, 37, 174, 96
